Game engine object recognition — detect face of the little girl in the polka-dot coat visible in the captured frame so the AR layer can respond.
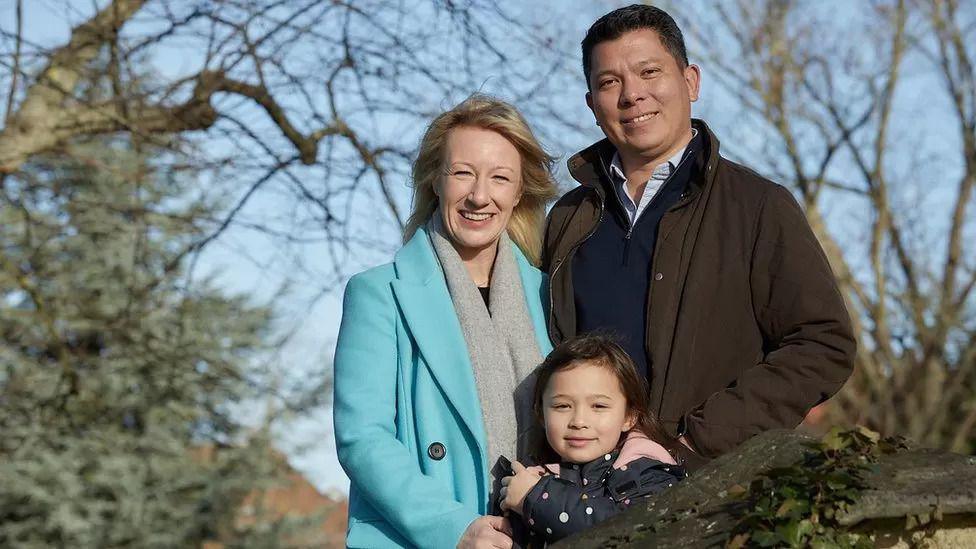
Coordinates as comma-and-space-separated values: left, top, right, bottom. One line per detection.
542, 362, 636, 463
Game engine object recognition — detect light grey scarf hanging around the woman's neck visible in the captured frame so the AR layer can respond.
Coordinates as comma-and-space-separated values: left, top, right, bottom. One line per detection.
427, 216, 542, 486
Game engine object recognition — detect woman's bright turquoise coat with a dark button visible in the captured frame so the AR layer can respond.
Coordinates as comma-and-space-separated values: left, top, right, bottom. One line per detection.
333, 228, 552, 548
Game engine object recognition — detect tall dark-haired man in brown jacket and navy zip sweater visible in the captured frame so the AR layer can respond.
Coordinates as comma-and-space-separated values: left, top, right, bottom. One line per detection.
543, 5, 855, 468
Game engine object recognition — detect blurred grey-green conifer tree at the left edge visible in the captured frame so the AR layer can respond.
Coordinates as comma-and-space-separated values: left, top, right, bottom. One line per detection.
0, 141, 310, 547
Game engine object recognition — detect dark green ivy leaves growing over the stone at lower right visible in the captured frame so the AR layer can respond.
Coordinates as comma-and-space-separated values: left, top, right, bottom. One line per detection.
728, 427, 903, 549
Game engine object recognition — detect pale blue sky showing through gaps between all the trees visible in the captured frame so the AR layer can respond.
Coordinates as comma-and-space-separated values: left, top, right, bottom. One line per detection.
0, 0, 958, 492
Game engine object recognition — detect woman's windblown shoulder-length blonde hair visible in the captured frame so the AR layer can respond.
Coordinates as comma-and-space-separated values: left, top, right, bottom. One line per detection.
403, 93, 556, 265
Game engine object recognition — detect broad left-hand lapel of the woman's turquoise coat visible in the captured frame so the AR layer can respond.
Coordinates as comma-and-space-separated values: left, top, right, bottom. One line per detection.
392, 227, 486, 455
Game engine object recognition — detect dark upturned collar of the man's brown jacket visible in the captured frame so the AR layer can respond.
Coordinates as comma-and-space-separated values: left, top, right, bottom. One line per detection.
566, 118, 719, 194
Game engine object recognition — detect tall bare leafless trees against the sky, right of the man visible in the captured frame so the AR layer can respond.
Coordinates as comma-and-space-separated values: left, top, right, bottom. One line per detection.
680, 0, 976, 451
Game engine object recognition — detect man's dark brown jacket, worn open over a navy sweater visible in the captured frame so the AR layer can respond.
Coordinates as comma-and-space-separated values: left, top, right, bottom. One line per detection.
542, 120, 855, 467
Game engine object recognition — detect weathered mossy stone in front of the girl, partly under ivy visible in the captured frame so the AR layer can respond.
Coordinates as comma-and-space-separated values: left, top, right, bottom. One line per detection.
556, 430, 976, 549
